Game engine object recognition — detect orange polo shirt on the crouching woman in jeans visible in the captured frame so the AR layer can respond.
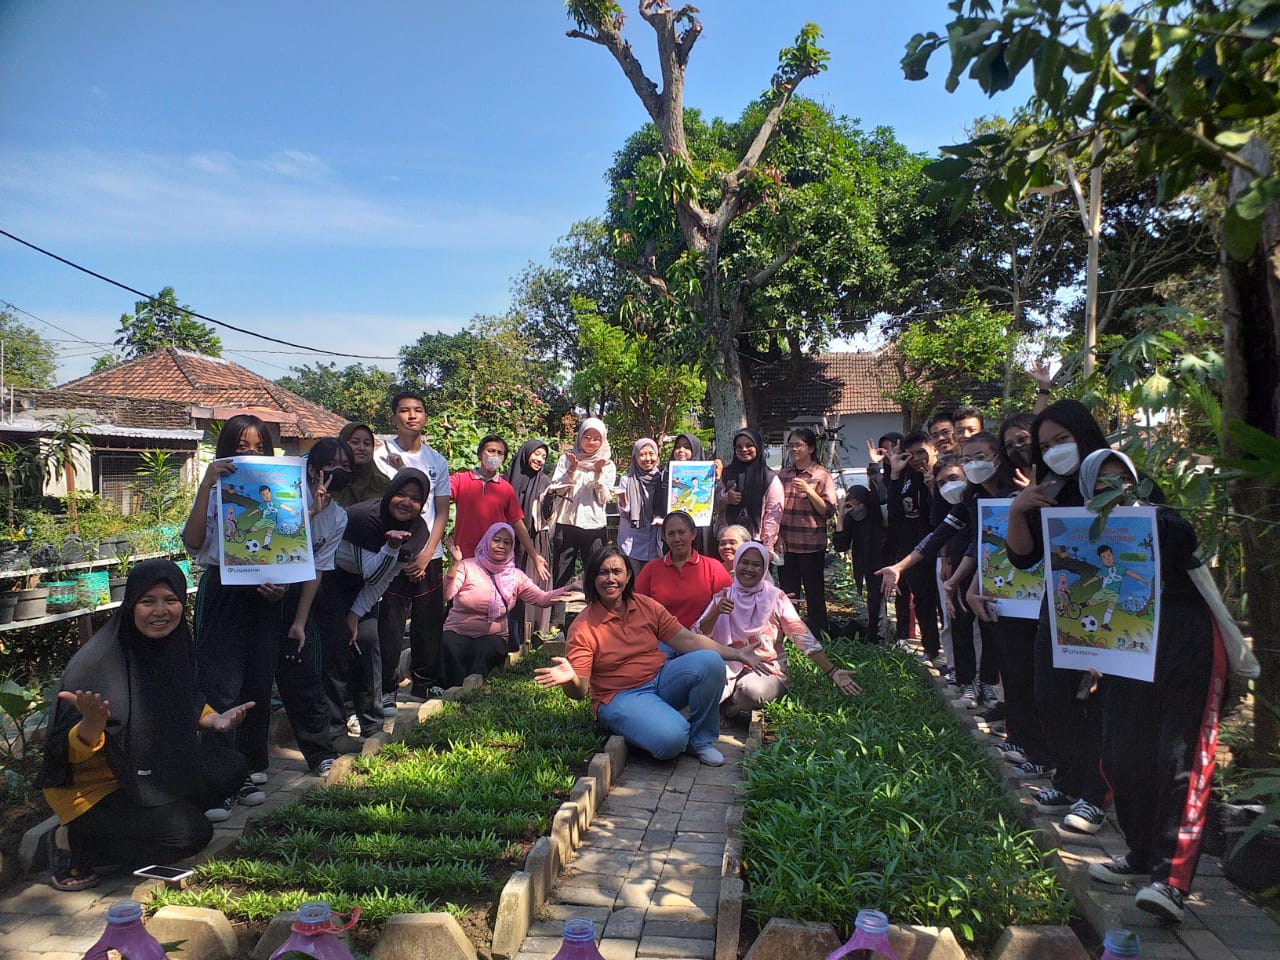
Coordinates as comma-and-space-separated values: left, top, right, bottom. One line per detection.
566, 594, 682, 713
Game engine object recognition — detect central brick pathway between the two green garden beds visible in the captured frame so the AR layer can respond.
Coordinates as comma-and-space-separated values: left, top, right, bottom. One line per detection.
517, 731, 745, 960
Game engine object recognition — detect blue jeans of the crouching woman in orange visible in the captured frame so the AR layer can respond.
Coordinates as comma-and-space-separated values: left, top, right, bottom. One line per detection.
595, 650, 724, 760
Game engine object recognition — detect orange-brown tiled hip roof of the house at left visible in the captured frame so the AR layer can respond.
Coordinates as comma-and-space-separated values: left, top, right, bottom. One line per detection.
63, 347, 347, 438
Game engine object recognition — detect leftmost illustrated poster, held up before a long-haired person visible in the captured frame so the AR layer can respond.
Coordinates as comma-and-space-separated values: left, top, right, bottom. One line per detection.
216, 457, 316, 584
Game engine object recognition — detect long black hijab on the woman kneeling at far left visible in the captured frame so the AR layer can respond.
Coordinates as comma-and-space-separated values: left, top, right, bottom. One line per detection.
36, 559, 205, 806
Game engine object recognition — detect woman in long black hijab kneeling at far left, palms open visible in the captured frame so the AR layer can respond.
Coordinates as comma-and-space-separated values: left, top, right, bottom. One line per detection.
37, 559, 253, 890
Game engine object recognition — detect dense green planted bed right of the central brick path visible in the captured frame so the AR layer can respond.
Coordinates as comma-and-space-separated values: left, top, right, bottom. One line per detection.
742, 639, 1070, 948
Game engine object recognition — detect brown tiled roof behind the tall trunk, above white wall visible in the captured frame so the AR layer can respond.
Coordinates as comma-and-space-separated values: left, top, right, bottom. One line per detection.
754, 347, 902, 425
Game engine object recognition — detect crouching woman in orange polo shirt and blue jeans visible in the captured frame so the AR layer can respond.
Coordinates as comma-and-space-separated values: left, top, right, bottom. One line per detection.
534, 544, 765, 767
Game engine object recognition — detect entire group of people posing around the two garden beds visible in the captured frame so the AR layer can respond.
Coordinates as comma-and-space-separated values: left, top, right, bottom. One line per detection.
41, 385, 1220, 918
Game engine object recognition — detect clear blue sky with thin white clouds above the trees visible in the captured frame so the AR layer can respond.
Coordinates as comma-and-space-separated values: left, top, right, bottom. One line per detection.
0, 0, 1020, 380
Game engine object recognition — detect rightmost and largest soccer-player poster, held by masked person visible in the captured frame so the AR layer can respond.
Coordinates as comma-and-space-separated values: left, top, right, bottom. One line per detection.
1041, 507, 1160, 682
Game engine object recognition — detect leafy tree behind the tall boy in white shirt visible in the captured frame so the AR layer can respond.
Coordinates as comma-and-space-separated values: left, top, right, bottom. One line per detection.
401, 316, 567, 454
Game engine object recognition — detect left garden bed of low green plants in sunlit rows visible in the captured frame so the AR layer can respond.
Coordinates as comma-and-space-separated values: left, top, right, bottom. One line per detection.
150, 653, 604, 923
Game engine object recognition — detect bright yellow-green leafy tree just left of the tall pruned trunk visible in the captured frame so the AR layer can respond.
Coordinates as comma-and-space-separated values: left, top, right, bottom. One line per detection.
570, 300, 707, 445
